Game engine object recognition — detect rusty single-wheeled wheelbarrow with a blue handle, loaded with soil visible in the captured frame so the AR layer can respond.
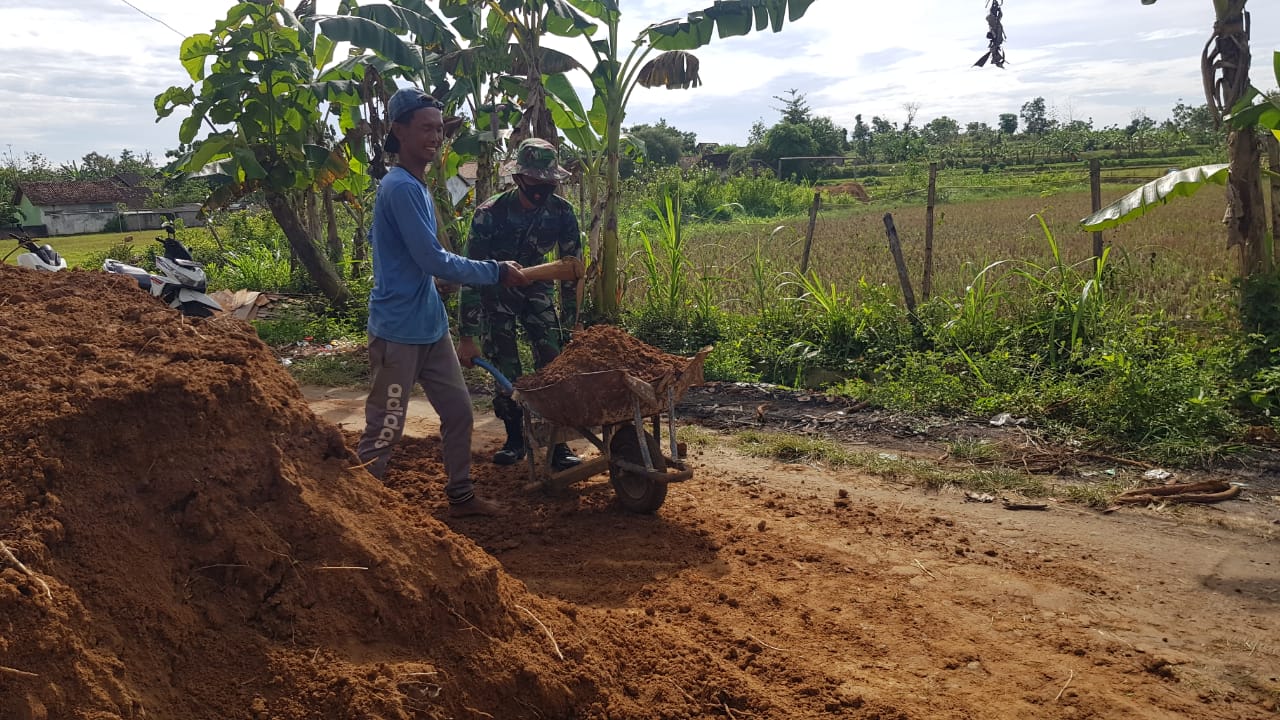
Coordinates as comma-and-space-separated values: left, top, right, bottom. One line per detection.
476, 347, 712, 512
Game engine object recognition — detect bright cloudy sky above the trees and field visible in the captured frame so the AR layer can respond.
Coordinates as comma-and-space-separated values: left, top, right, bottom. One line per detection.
0, 0, 1280, 163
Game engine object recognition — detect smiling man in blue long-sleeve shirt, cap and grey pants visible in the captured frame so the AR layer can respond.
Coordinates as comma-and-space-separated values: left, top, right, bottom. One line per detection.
356, 88, 529, 515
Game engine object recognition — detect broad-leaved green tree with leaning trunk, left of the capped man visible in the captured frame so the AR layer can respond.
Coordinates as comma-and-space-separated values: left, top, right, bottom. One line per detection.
155, 0, 376, 305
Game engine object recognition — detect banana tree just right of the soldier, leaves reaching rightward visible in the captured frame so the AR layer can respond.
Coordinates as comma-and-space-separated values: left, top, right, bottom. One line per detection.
566, 0, 815, 316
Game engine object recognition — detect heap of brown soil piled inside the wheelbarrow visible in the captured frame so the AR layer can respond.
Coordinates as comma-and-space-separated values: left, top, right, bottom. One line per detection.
516, 325, 689, 389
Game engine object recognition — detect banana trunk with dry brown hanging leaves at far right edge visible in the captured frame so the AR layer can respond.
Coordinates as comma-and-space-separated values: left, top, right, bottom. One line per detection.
1142, 0, 1272, 277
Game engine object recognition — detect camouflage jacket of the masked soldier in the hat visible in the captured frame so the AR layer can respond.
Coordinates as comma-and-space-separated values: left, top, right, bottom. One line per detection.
458, 188, 582, 337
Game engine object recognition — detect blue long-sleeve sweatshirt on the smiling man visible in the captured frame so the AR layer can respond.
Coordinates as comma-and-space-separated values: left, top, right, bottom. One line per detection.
369, 167, 499, 345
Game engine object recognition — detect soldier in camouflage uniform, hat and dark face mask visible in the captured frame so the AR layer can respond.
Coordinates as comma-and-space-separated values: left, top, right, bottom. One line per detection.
458, 138, 582, 469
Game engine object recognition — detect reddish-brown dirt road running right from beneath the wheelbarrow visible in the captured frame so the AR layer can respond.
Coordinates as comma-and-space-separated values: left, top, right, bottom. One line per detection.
306, 388, 1280, 719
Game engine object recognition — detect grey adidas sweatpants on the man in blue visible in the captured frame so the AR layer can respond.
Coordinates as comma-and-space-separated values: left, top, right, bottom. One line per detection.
356, 334, 475, 503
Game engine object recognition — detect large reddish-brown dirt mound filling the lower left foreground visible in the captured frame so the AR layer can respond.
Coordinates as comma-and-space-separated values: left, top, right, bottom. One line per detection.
0, 266, 762, 720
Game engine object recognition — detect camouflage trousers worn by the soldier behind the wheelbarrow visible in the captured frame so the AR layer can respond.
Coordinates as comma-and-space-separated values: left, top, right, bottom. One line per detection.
484, 285, 563, 420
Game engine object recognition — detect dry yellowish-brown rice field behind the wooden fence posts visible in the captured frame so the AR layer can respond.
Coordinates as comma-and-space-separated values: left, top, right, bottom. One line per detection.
640, 186, 1238, 323
